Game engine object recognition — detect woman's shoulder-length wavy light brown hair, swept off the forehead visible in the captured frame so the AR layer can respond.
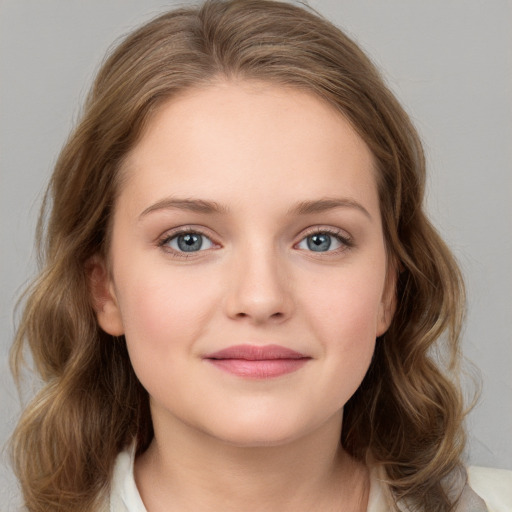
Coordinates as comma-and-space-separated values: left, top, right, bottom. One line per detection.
11, 0, 465, 512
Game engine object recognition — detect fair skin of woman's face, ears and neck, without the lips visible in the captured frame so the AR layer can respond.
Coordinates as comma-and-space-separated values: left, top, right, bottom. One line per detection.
91, 81, 394, 512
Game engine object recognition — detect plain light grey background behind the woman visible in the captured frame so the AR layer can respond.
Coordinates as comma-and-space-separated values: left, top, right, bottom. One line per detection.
0, 0, 512, 511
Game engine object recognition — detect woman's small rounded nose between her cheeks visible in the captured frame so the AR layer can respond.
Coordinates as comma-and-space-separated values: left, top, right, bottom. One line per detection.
225, 246, 293, 324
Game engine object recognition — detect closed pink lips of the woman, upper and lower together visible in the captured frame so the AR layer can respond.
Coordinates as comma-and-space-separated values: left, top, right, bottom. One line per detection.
204, 345, 311, 379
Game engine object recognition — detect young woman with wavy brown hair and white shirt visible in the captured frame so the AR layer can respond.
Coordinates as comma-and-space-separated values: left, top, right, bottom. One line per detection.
9, 0, 512, 512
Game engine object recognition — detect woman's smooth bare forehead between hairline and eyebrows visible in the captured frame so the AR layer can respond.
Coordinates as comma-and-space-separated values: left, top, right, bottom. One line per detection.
119, 81, 375, 215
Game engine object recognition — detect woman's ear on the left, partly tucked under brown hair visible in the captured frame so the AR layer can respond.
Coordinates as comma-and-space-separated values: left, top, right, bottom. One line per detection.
85, 255, 124, 336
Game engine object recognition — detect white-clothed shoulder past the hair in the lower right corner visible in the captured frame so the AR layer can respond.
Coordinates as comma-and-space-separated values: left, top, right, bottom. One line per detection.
468, 466, 512, 512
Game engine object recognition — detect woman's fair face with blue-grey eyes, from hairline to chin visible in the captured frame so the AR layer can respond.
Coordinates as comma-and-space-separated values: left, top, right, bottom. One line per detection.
96, 82, 394, 446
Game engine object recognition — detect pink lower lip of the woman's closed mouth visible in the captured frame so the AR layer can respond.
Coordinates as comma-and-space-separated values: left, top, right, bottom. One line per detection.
207, 357, 310, 379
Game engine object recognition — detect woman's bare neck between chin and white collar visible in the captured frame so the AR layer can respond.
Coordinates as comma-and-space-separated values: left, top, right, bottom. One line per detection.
135, 408, 368, 512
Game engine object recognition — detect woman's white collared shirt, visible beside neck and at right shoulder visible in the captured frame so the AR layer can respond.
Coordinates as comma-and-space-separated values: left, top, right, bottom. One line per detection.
109, 449, 512, 512
